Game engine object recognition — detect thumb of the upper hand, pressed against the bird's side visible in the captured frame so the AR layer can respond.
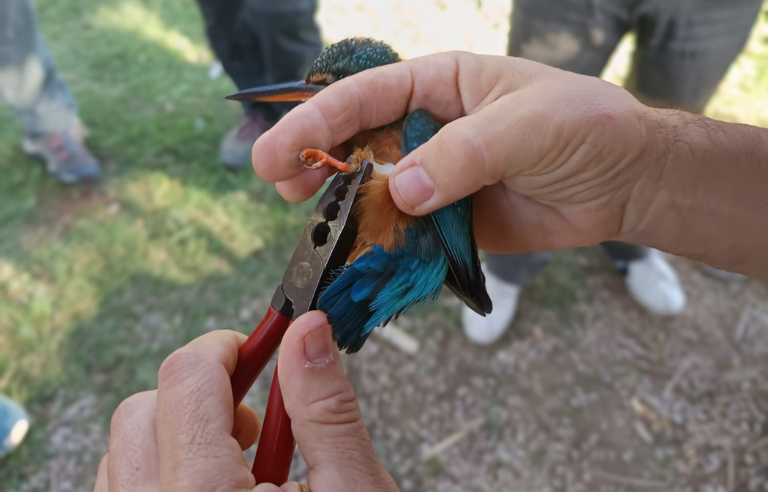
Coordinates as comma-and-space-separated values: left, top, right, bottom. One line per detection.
389, 100, 515, 215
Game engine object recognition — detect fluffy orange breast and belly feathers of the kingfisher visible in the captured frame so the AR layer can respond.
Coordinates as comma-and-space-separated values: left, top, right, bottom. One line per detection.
349, 122, 415, 261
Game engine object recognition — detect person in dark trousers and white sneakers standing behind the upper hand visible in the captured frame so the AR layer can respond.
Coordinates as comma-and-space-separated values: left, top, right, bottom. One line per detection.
462, 0, 762, 345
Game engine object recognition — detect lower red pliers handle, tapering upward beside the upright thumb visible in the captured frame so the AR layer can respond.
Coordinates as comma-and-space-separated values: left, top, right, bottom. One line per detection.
251, 367, 296, 487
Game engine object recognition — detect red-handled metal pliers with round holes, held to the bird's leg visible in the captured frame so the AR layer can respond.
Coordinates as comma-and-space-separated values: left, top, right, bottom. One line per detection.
231, 161, 373, 486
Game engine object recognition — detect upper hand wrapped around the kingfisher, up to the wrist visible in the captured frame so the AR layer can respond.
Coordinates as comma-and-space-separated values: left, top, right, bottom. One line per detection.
253, 43, 656, 253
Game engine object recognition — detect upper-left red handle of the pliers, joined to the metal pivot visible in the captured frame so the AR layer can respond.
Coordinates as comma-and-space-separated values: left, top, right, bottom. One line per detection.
230, 306, 291, 408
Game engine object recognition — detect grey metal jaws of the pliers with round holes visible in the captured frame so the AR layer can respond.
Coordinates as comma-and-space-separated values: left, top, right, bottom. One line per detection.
272, 161, 373, 319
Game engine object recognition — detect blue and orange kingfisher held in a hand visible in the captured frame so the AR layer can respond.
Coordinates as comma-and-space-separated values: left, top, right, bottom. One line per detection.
229, 38, 492, 353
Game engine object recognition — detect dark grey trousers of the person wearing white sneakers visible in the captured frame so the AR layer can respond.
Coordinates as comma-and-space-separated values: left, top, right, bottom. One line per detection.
487, 0, 763, 285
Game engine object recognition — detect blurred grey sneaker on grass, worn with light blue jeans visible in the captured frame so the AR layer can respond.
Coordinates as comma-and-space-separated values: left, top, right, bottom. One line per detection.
22, 127, 101, 184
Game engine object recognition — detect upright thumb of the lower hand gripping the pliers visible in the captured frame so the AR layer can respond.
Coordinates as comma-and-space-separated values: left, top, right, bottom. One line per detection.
278, 311, 398, 492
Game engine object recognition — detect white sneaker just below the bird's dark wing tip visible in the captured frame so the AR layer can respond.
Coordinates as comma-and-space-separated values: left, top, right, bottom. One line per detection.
461, 265, 520, 345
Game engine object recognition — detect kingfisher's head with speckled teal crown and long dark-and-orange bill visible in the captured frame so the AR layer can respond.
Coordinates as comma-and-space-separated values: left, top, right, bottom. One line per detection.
227, 38, 400, 102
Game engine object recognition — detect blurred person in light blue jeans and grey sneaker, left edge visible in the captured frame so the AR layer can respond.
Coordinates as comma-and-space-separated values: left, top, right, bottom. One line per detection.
0, 0, 100, 184
